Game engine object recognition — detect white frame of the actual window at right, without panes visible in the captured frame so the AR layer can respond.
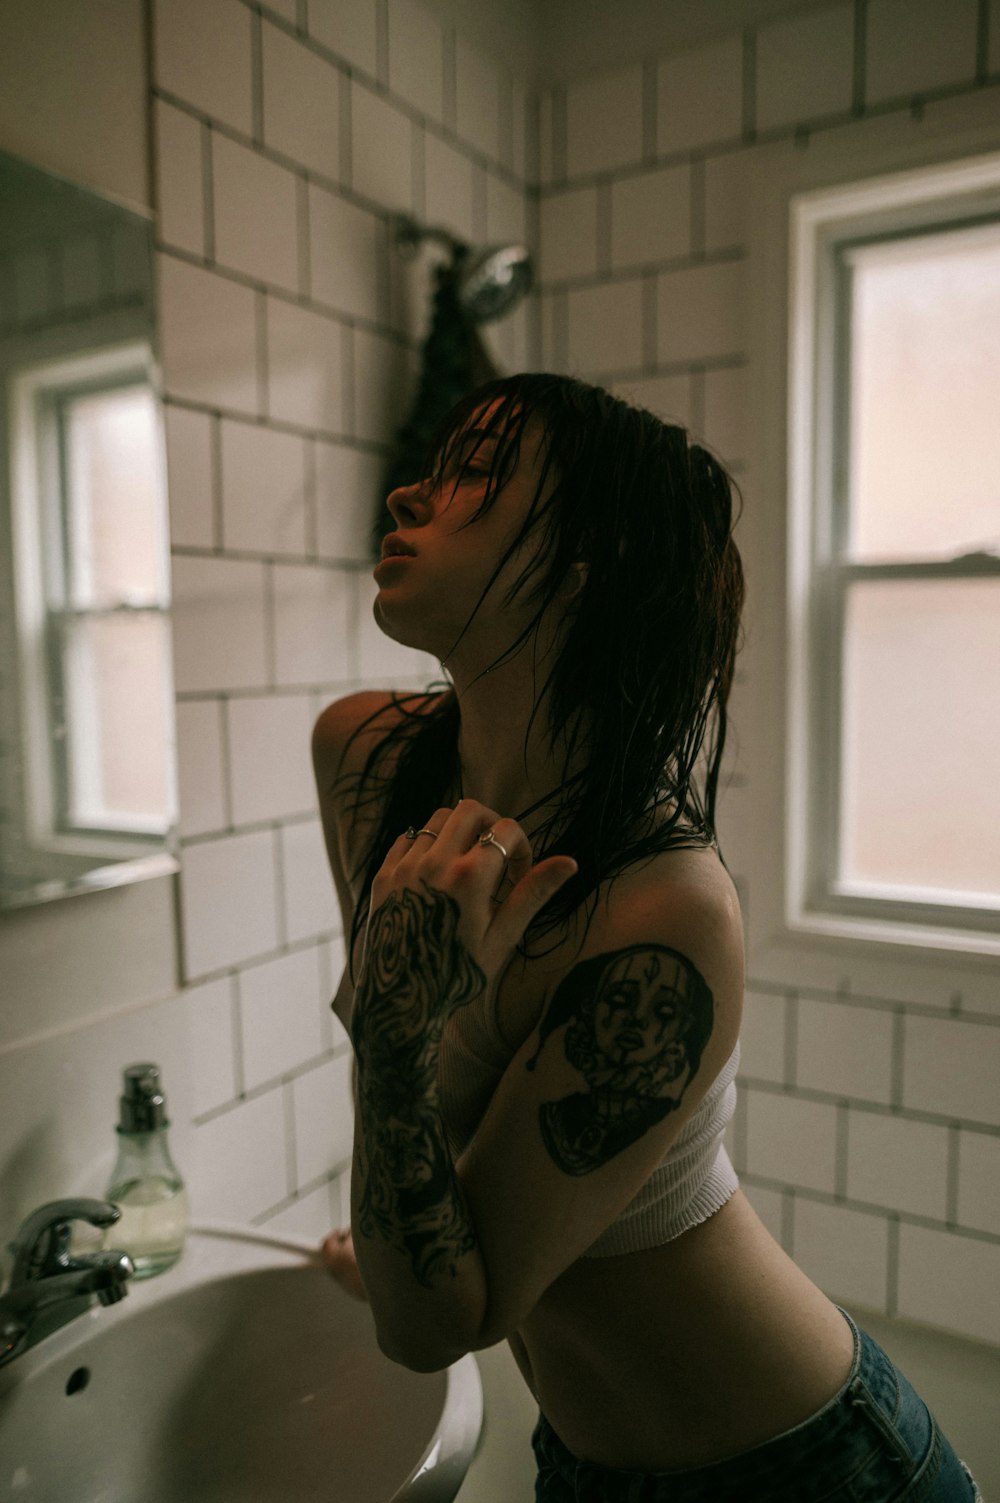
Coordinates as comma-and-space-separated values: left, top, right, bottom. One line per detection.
783, 153, 1000, 954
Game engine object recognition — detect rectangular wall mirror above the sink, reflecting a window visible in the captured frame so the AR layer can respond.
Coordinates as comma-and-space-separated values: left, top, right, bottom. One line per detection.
0, 153, 177, 908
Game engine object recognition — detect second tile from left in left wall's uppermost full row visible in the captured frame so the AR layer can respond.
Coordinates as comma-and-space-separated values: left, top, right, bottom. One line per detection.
262, 21, 347, 182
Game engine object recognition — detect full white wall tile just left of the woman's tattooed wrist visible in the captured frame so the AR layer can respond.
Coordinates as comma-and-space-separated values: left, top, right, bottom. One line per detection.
236, 950, 323, 1091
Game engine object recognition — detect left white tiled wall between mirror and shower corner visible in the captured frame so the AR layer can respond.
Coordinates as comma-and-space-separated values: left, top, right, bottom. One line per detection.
154, 0, 529, 1238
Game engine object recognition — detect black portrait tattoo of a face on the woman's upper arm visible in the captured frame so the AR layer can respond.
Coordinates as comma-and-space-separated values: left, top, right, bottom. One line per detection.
528, 944, 714, 1175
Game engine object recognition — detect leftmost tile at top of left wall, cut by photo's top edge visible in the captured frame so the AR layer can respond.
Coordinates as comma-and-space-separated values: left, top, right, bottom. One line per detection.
153, 0, 253, 135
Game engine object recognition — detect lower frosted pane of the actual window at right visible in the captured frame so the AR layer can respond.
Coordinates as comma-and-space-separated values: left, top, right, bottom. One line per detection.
839, 579, 1000, 903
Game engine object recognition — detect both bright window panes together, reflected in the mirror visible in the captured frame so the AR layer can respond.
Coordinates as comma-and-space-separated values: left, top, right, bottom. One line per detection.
48, 368, 176, 834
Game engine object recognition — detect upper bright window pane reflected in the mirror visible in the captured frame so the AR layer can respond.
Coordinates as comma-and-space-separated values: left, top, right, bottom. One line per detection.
63, 386, 165, 607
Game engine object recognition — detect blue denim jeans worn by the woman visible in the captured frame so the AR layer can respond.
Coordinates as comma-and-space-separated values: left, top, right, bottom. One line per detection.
532, 1311, 982, 1503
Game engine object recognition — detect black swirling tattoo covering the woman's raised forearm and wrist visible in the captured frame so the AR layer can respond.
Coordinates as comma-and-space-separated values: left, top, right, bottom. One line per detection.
352, 882, 486, 1287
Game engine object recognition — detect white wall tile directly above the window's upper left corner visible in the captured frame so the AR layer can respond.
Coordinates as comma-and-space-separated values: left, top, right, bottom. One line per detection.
756, 3, 856, 131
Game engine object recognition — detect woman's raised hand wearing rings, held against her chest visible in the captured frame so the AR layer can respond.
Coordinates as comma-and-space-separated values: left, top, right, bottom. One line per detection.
362, 798, 577, 1010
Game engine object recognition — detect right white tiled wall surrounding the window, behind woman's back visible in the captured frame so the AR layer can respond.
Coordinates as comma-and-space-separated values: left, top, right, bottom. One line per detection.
537, 11, 1000, 1341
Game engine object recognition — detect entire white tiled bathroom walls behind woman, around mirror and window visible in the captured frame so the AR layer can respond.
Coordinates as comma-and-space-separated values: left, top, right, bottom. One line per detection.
0, 0, 1000, 1503
